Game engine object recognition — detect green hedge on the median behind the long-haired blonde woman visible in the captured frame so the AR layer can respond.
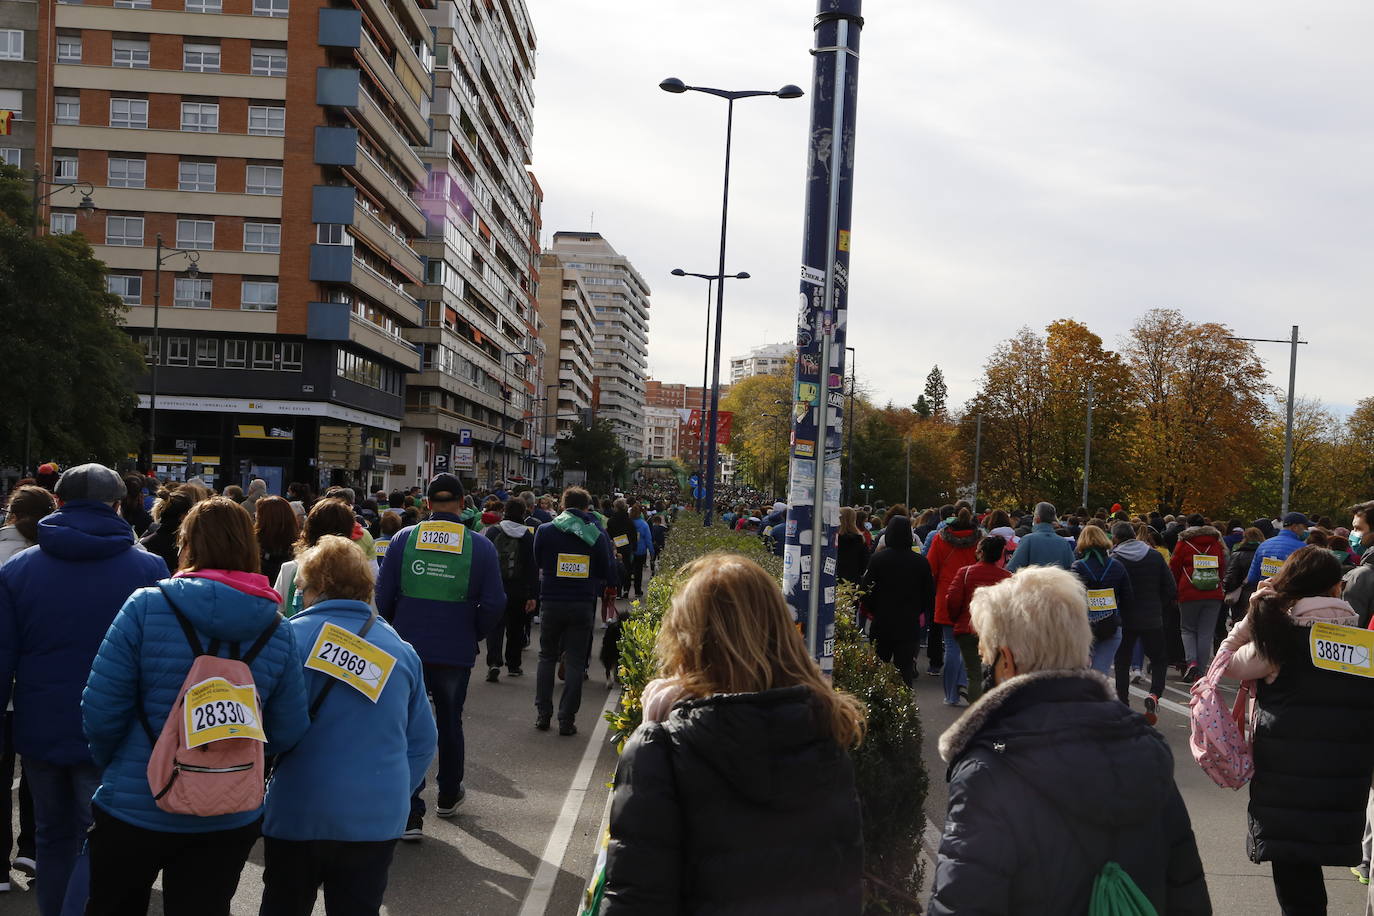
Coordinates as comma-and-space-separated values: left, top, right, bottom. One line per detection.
606, 514, 927, 915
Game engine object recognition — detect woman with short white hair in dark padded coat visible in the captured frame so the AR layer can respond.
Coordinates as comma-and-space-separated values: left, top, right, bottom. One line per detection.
929, 567, 1212, 916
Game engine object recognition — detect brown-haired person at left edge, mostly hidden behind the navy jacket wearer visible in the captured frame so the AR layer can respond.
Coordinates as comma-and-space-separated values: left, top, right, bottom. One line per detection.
0, 483, 58, 893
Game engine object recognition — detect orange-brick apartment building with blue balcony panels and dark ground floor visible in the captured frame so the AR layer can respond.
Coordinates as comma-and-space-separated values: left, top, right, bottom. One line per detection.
29, 0, 434, 492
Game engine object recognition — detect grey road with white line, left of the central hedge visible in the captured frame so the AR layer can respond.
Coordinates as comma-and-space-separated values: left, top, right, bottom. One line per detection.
0, 628, 618, 916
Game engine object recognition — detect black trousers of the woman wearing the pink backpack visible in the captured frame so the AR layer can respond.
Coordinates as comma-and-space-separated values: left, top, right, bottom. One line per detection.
83, 805, 262, 916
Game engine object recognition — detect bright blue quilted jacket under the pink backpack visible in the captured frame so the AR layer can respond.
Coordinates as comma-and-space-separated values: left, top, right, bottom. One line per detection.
81, 570, 311, 834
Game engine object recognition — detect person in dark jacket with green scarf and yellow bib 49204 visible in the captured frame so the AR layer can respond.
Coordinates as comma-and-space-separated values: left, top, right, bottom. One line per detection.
534, 486, 628, 736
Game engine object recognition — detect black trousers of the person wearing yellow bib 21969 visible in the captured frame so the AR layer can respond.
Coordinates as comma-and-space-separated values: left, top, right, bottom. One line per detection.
258, 836, 396, 916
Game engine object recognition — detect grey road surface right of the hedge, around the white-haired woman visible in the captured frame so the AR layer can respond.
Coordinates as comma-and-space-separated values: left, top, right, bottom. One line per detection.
916, 654, 1367, 916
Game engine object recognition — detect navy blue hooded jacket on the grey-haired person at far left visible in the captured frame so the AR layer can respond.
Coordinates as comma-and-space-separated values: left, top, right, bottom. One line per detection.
0, 500, 168, 766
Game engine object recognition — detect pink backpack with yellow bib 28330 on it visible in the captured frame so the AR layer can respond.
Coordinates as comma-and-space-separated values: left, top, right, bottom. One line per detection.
139, 589, 282, 817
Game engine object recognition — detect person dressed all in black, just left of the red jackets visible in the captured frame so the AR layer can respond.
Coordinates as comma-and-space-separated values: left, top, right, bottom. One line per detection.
863, 515, 936, 687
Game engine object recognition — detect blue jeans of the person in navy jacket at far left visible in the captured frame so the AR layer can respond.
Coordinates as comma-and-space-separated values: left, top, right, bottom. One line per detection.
23, 757, 100, 916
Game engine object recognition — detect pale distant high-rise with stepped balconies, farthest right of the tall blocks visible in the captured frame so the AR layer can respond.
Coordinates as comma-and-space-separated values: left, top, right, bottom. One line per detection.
550, 232, 650, 457
